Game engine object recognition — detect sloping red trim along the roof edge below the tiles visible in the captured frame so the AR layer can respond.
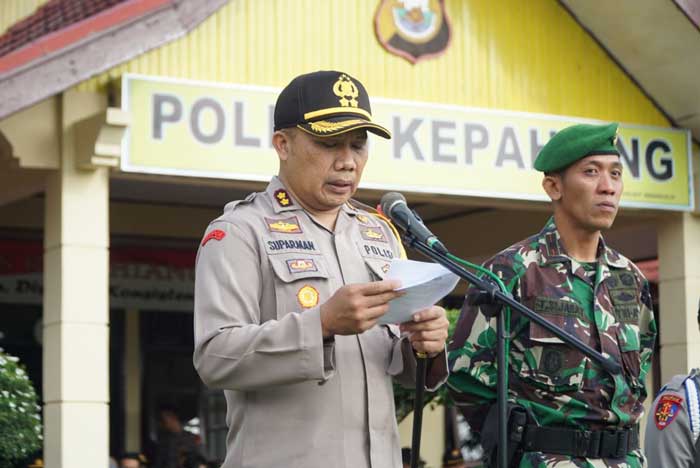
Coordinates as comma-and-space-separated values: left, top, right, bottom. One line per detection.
0, 0, 173, 74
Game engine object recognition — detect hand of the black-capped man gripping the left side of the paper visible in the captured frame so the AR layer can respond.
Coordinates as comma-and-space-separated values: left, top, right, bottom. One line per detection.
321, 280, 403, 338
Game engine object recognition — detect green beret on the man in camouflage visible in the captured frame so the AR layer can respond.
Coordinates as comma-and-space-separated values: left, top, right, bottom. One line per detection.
535, 123, 620, 172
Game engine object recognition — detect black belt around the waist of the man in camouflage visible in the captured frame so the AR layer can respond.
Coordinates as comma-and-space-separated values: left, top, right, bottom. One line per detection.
522, 425, 639, 458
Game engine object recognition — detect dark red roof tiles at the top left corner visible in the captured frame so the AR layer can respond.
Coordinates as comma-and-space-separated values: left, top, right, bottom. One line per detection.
0, 0, 127, 57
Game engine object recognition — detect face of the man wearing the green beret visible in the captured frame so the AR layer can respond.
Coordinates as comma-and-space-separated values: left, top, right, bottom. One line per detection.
548, 154, 623, 232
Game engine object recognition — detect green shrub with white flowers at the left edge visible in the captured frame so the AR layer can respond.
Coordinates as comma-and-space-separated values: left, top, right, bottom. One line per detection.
0, 348, 42, 466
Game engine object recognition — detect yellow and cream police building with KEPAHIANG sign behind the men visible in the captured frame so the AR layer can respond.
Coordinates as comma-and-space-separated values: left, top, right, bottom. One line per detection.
0, 0, 700, 468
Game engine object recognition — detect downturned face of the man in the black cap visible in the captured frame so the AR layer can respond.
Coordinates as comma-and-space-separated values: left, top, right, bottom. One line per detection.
272, 129, 367, 212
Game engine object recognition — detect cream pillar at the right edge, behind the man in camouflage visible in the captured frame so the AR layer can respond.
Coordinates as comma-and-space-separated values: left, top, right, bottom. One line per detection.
659, 213, 700, 384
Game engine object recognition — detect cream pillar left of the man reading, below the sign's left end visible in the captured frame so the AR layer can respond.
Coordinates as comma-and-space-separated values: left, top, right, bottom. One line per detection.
43, 91, 109, 468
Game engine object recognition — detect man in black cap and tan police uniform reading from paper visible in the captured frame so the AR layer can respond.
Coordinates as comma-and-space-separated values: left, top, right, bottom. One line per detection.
194, 71, 448, 468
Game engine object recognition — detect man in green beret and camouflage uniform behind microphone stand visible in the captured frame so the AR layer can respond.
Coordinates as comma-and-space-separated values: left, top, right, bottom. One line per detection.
448, 124, 656, 468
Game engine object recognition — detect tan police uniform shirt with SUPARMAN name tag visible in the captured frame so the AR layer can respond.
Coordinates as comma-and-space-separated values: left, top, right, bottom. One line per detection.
194, 177, 444, 468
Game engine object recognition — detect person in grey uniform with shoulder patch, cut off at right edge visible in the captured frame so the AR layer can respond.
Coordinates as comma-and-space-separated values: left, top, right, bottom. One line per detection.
644, 304, 700, 468
